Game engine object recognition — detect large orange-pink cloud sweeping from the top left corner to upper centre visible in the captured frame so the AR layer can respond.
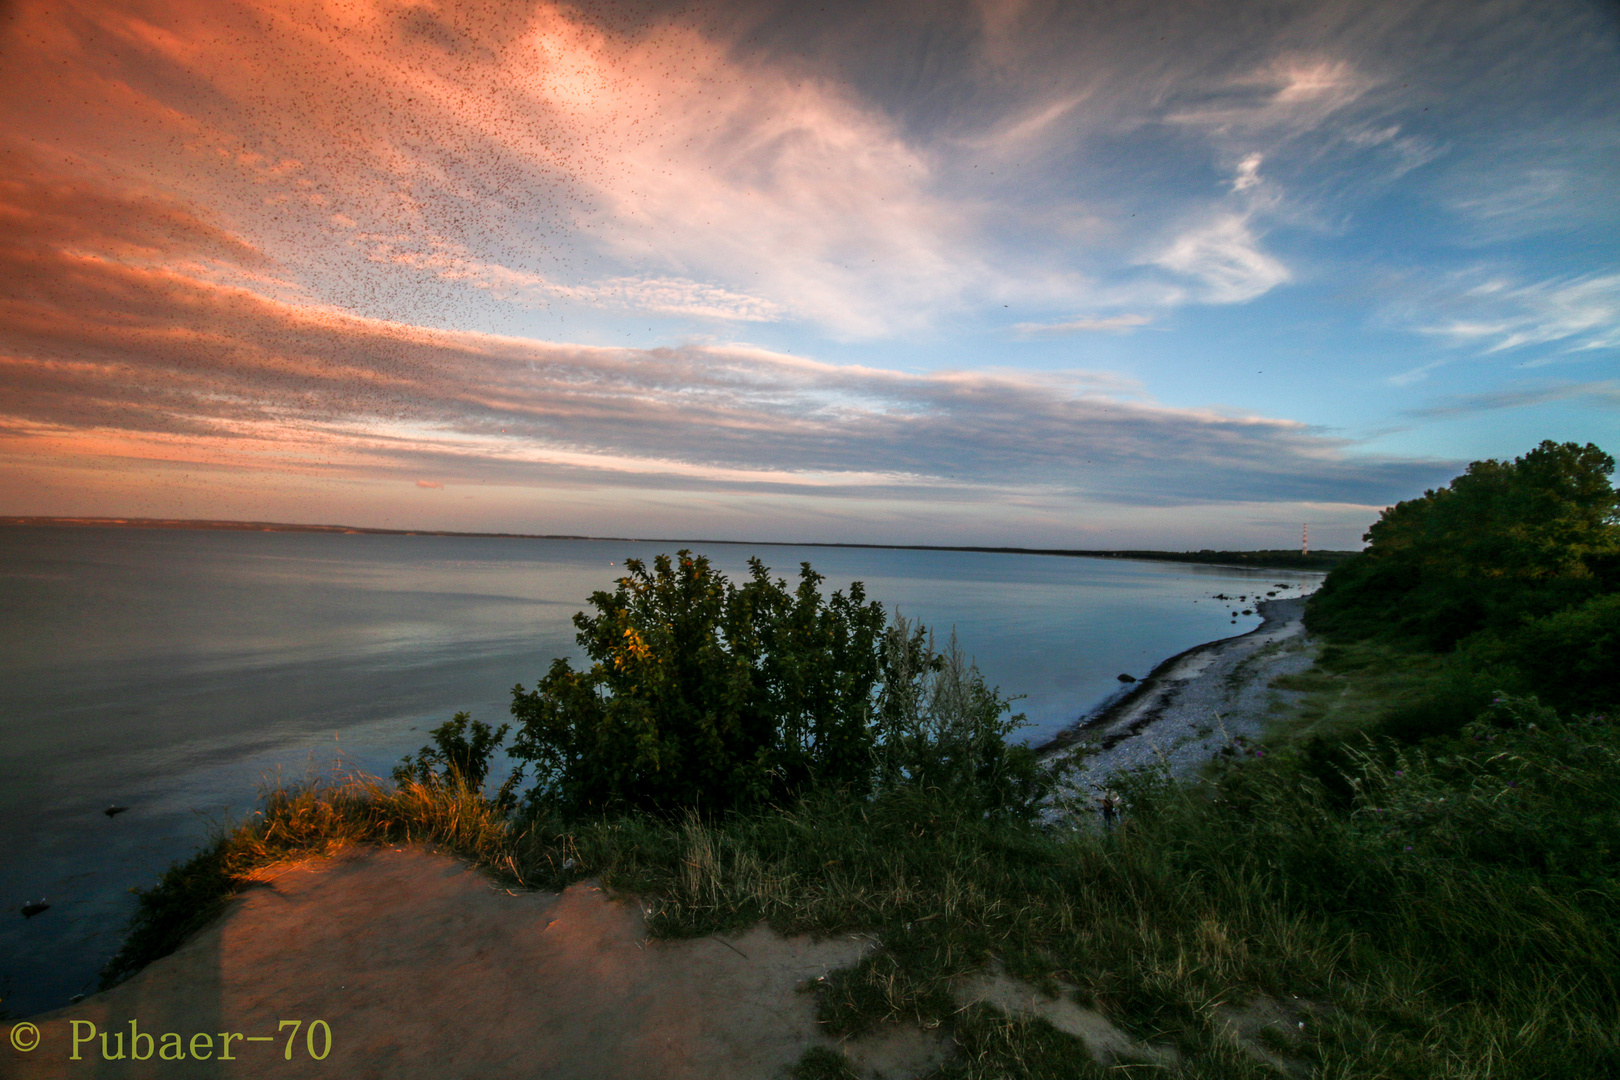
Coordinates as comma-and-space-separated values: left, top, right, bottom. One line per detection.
0, 0, 985, 337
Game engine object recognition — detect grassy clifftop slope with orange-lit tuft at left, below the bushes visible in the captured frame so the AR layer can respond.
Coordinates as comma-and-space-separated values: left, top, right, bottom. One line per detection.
109, 646, 1620, 1078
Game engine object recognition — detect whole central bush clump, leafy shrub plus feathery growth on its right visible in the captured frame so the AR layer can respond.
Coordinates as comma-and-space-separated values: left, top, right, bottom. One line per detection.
498, 551, 1040, 814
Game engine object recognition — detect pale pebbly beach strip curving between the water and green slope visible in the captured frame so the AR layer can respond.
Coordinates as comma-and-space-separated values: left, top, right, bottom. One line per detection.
1035, 597, 1312, 809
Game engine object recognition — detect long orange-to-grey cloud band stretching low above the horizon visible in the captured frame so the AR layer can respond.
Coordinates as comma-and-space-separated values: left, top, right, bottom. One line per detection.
0, 173, 1437, 505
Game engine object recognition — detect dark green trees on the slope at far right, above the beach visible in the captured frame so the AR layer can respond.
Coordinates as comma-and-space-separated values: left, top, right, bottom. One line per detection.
1307, 440, 1620, 730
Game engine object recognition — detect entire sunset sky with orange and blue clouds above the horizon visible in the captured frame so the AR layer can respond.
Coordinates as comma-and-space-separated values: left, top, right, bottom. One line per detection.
0, 0, 1620, 549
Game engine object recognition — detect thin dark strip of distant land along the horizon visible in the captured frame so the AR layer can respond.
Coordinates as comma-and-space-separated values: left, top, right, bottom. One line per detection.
0, 517, 1359, 570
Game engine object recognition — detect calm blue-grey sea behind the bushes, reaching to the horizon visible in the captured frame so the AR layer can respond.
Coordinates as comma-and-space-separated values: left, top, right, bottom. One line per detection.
0, 528, 1319, 1017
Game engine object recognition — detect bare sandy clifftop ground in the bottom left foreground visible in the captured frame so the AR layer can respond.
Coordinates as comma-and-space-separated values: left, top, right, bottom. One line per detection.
0, 848, 915, 1080
